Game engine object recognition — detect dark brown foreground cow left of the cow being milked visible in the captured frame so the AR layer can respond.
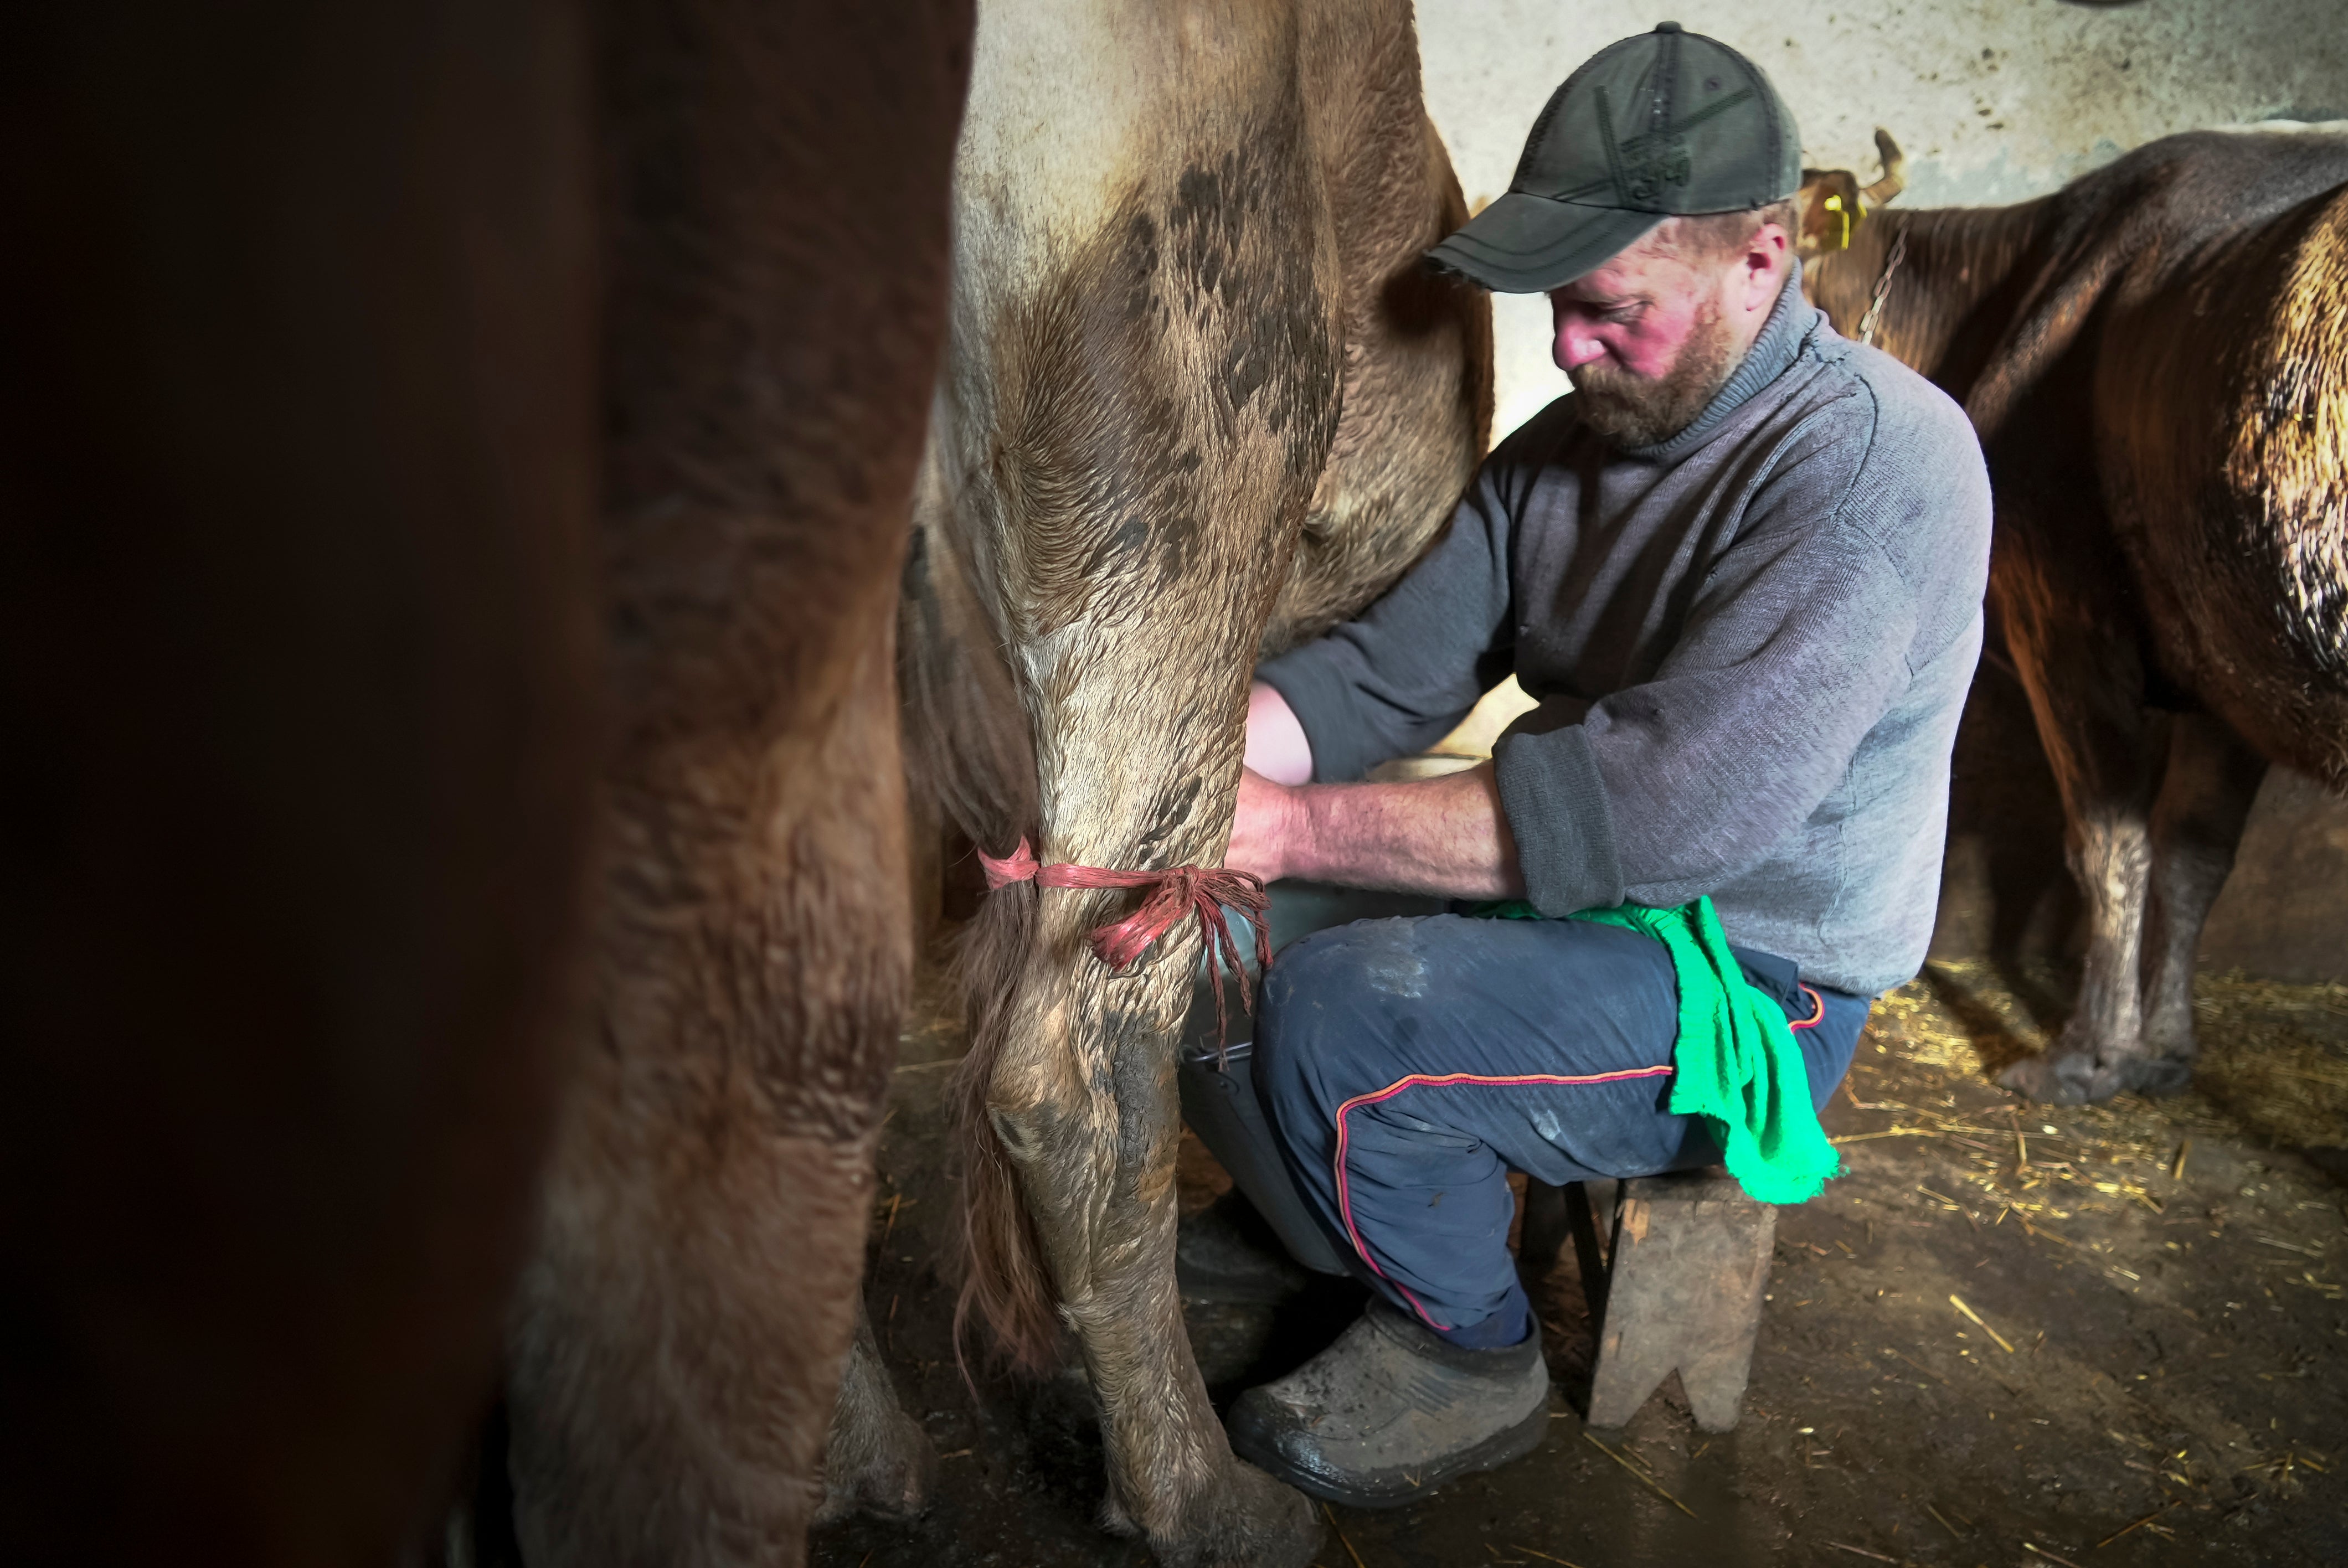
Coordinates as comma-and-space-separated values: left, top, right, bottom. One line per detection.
0, 0, 970, 1568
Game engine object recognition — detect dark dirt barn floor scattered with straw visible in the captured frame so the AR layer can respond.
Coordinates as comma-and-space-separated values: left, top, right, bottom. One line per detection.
815, 948, 2348, 1568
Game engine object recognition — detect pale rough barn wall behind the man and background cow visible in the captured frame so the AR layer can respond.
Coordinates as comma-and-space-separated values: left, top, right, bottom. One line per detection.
1418, 0, 2348, 979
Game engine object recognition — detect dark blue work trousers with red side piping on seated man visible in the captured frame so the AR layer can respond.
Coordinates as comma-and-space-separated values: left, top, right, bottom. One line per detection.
1252, 915, 1869, 1345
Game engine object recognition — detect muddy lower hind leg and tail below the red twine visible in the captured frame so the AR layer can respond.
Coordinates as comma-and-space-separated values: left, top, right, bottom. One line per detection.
962, 868, 1322, 1568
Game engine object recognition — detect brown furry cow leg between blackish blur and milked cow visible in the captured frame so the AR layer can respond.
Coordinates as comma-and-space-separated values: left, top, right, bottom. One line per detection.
507, 0, 970, 1568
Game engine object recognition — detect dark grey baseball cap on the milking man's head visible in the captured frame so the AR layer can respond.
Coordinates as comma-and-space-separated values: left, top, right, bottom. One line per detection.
1428, 21, 1801, 293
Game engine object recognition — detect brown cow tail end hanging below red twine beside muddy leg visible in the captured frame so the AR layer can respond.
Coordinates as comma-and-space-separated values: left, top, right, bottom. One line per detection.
953, 883, 1059, 1375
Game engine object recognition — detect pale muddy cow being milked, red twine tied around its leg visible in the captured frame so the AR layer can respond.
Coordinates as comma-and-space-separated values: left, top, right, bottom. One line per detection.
883, 0, 1491, 1566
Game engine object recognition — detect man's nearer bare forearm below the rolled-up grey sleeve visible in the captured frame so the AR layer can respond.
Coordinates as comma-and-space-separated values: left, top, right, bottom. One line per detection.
1280, 763, 1524, 899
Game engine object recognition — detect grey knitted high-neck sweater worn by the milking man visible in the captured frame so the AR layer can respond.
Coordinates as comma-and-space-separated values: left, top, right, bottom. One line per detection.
1259, 280, 1989, 996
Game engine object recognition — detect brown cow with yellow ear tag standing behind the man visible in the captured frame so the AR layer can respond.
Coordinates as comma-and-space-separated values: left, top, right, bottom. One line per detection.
1806, 125, 2348, 1101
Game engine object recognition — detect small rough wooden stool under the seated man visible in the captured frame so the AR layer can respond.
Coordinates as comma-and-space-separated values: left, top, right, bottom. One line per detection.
1524, 1167, 1778, 1432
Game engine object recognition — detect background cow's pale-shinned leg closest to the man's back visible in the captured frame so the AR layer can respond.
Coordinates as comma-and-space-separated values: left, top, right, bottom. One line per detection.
1991, 551, 2167, 1103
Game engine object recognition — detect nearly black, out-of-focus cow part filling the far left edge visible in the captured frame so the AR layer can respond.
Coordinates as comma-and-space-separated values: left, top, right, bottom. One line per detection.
0, 0, 596, 1568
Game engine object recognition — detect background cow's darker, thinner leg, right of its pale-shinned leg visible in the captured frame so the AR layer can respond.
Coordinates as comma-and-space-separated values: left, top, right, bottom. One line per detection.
2144, 714, 2266, 1091
